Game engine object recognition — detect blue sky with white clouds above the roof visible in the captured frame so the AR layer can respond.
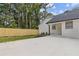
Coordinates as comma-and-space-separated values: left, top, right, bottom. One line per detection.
47, 3, 79, 15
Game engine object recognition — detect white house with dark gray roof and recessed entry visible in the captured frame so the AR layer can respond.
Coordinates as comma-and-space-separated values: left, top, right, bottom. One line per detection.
39, 9, 79, 38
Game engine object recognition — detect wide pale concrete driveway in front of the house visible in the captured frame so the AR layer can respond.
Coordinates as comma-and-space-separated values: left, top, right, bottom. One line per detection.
0, 36, 79, 56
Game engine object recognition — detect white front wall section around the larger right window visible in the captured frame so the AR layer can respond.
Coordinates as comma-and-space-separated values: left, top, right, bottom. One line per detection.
62, 19, 79, 38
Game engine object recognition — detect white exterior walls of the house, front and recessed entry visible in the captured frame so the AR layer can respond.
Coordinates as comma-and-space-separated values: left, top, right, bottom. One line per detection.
48, 19, 79, 38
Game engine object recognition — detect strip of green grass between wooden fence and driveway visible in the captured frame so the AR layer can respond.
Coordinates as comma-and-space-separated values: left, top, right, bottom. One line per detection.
0, 35, 37, 43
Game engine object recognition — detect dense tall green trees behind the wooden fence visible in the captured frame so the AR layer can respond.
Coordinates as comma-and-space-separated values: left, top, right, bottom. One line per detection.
0, 3, 52, 29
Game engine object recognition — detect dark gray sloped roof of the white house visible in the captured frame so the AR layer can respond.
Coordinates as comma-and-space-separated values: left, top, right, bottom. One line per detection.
47, 9, 79, 23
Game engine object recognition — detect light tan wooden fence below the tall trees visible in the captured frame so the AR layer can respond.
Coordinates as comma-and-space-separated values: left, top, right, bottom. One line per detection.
0, 28, 38, 36
